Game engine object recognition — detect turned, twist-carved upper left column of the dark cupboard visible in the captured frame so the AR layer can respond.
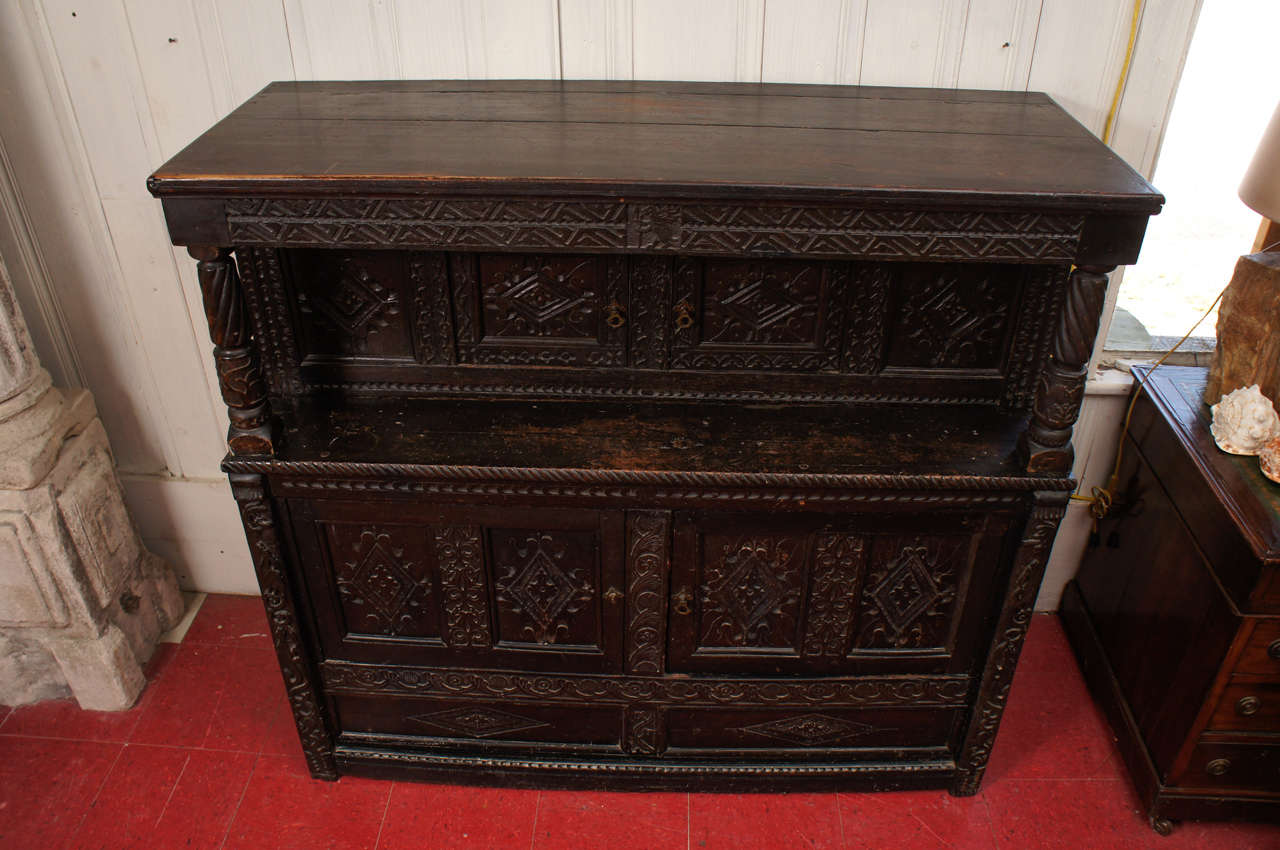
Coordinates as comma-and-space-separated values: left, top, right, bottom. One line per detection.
187, 246, 274, 454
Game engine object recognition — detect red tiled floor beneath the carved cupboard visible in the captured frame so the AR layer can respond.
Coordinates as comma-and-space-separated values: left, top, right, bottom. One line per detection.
0, 597, 1280, 850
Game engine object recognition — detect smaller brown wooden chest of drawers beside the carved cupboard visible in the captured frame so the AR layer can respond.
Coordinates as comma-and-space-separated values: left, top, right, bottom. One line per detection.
1062, 366, 1280, 831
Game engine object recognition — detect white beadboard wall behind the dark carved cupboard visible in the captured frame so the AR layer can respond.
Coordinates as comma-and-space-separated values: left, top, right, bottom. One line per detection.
0, 0, 1201, 596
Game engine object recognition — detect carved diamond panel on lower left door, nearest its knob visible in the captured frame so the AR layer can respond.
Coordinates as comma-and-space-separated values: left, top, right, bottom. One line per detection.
492, 529, 599, 645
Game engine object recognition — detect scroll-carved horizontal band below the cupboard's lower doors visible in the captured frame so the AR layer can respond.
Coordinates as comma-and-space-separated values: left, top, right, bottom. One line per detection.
321, 661, 972, 708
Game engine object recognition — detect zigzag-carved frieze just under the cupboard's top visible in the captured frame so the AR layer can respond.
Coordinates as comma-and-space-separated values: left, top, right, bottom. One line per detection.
227, 198, 1084, 262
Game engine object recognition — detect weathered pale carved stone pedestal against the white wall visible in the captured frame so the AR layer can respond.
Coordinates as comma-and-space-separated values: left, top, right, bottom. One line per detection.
0, 258, 183, 710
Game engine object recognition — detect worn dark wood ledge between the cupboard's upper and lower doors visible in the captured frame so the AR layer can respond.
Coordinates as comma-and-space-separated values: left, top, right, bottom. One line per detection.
279, 398, 1025, 476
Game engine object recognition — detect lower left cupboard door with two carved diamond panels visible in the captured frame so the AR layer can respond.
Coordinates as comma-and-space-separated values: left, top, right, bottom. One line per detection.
289, 499, 625, 672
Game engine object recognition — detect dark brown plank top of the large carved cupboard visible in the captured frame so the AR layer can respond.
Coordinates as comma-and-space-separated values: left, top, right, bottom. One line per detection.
148, 81, 1164, 214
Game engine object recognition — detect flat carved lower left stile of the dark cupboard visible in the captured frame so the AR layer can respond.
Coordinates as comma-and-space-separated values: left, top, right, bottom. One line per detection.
229, 472, 338, 781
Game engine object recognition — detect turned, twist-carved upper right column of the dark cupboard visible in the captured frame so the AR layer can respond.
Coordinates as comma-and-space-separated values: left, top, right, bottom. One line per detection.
1020, 266, 1115, 475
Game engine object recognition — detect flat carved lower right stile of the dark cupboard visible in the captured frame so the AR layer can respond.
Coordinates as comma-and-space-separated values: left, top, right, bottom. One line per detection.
951, 490, 1070, 796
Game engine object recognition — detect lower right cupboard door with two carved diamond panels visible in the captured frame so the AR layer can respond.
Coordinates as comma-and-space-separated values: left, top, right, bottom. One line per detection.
668, 512, 1012, 673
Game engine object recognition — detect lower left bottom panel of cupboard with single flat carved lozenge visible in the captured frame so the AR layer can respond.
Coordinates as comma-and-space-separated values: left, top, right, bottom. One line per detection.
334, 695, 625, 750
